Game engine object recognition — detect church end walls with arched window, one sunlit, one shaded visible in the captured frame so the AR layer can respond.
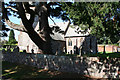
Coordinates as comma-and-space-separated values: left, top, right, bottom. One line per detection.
66, 36, 97, 54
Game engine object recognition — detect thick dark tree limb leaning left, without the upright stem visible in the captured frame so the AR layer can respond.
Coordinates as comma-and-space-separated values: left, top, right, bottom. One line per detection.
16, 2, 45, 50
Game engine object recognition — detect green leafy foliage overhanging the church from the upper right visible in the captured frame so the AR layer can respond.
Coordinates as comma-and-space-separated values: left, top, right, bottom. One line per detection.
62, 2, 120, 44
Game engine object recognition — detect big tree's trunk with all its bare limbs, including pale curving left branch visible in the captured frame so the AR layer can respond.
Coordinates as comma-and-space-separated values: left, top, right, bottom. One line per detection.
2, 2, 70, 54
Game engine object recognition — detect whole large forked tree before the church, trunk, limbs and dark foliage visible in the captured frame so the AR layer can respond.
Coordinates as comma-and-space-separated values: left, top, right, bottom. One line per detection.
2, 2, 68, 54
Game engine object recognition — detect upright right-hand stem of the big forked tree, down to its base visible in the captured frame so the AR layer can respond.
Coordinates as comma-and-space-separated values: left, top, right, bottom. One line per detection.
39, 2, 52, 54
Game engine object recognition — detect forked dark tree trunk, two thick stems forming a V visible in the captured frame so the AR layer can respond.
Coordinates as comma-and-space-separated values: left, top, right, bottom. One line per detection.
17, 2, 52, 54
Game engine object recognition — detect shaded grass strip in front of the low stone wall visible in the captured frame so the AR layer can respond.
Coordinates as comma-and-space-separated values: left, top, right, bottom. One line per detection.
2, 61, 90, 80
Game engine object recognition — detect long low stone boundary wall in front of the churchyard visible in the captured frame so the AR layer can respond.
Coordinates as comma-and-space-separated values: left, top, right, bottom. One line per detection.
3, 50, 120, 78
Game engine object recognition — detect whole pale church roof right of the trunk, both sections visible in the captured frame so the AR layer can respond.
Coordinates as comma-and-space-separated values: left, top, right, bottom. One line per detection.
50, 22, 89, 41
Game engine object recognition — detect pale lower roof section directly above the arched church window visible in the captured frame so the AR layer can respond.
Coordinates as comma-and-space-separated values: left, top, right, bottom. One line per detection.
65, 26, 90, 37
